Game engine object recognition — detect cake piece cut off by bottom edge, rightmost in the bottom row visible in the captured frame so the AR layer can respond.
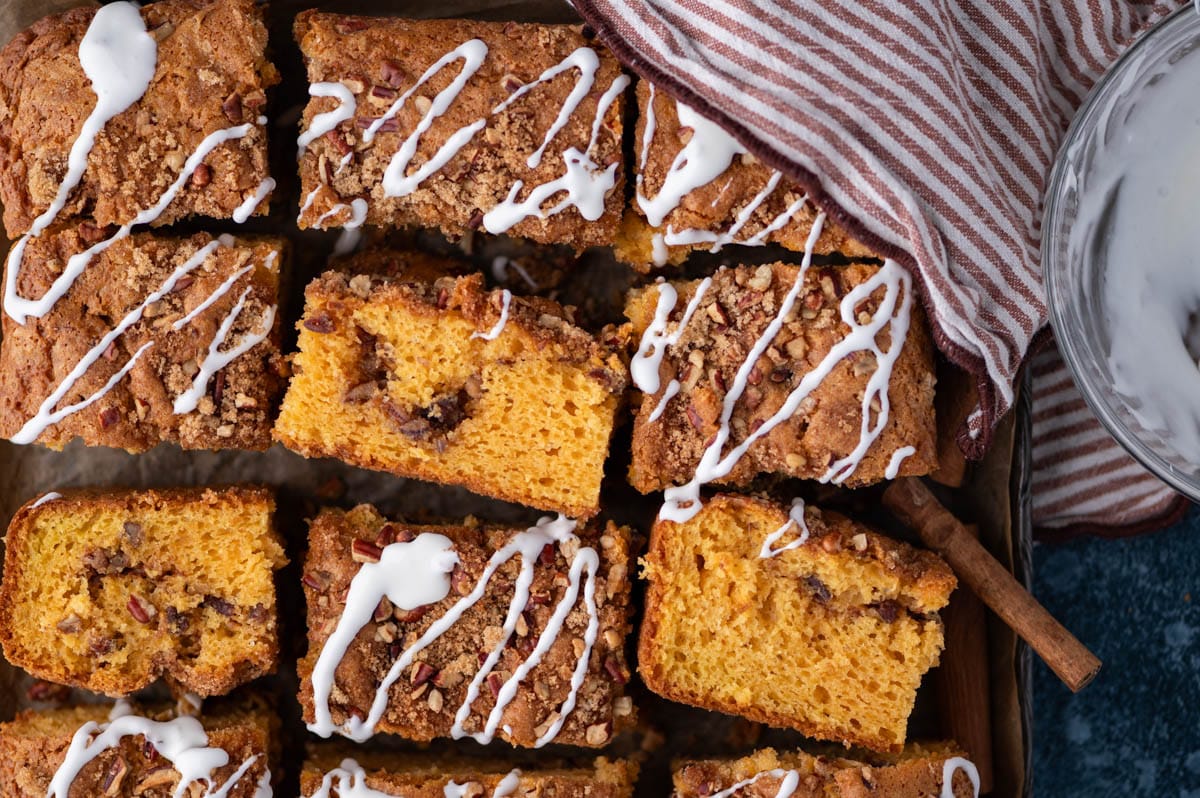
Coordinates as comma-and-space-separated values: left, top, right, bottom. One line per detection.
672, 743, 979, 798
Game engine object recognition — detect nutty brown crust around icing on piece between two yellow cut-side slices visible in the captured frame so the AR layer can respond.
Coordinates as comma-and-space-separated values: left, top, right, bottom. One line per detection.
299, 505, 634, 748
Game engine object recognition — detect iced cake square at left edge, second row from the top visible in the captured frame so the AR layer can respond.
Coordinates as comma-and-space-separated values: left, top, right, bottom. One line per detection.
0, 231, 286, 451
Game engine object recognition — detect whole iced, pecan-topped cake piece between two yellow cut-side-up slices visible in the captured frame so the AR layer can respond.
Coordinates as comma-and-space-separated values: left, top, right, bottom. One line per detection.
299, 505, 634, 748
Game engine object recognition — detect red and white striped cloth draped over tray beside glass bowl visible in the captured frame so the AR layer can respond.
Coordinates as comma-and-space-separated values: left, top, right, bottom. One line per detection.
572, 0, 1180, 529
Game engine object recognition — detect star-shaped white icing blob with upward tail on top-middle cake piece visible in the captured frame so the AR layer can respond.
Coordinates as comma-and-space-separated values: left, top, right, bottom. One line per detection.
484, 74, 629, 233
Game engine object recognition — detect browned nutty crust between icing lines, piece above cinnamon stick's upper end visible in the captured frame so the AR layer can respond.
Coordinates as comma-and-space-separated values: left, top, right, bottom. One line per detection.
625, 263, 937, 493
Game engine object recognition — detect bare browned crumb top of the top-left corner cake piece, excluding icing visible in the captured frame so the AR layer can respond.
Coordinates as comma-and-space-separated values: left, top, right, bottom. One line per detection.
0, 0, 278, 238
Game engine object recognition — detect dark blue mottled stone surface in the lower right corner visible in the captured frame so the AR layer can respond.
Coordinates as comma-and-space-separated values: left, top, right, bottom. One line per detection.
1033, 508, 1200, 798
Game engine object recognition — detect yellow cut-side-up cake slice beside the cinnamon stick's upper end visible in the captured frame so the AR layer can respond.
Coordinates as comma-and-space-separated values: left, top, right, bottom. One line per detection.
638, 496, 955, 751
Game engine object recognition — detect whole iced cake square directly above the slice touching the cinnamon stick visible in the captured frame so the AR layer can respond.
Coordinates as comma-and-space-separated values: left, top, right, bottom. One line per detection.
625, 262, 937, 502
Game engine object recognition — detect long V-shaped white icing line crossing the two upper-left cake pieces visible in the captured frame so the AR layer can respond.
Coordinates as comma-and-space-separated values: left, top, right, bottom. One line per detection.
4, 122, 253, 324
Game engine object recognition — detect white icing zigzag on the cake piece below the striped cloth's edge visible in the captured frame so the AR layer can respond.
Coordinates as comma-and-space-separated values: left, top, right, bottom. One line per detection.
652, 214, 912, 523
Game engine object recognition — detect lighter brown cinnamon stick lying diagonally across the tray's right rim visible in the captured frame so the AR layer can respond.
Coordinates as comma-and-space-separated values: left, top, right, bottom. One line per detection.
883, 476, 1100, 692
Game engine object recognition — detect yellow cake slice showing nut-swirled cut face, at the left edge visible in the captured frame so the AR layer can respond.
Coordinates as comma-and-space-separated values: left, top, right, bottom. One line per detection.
0, 487, 287, 696
